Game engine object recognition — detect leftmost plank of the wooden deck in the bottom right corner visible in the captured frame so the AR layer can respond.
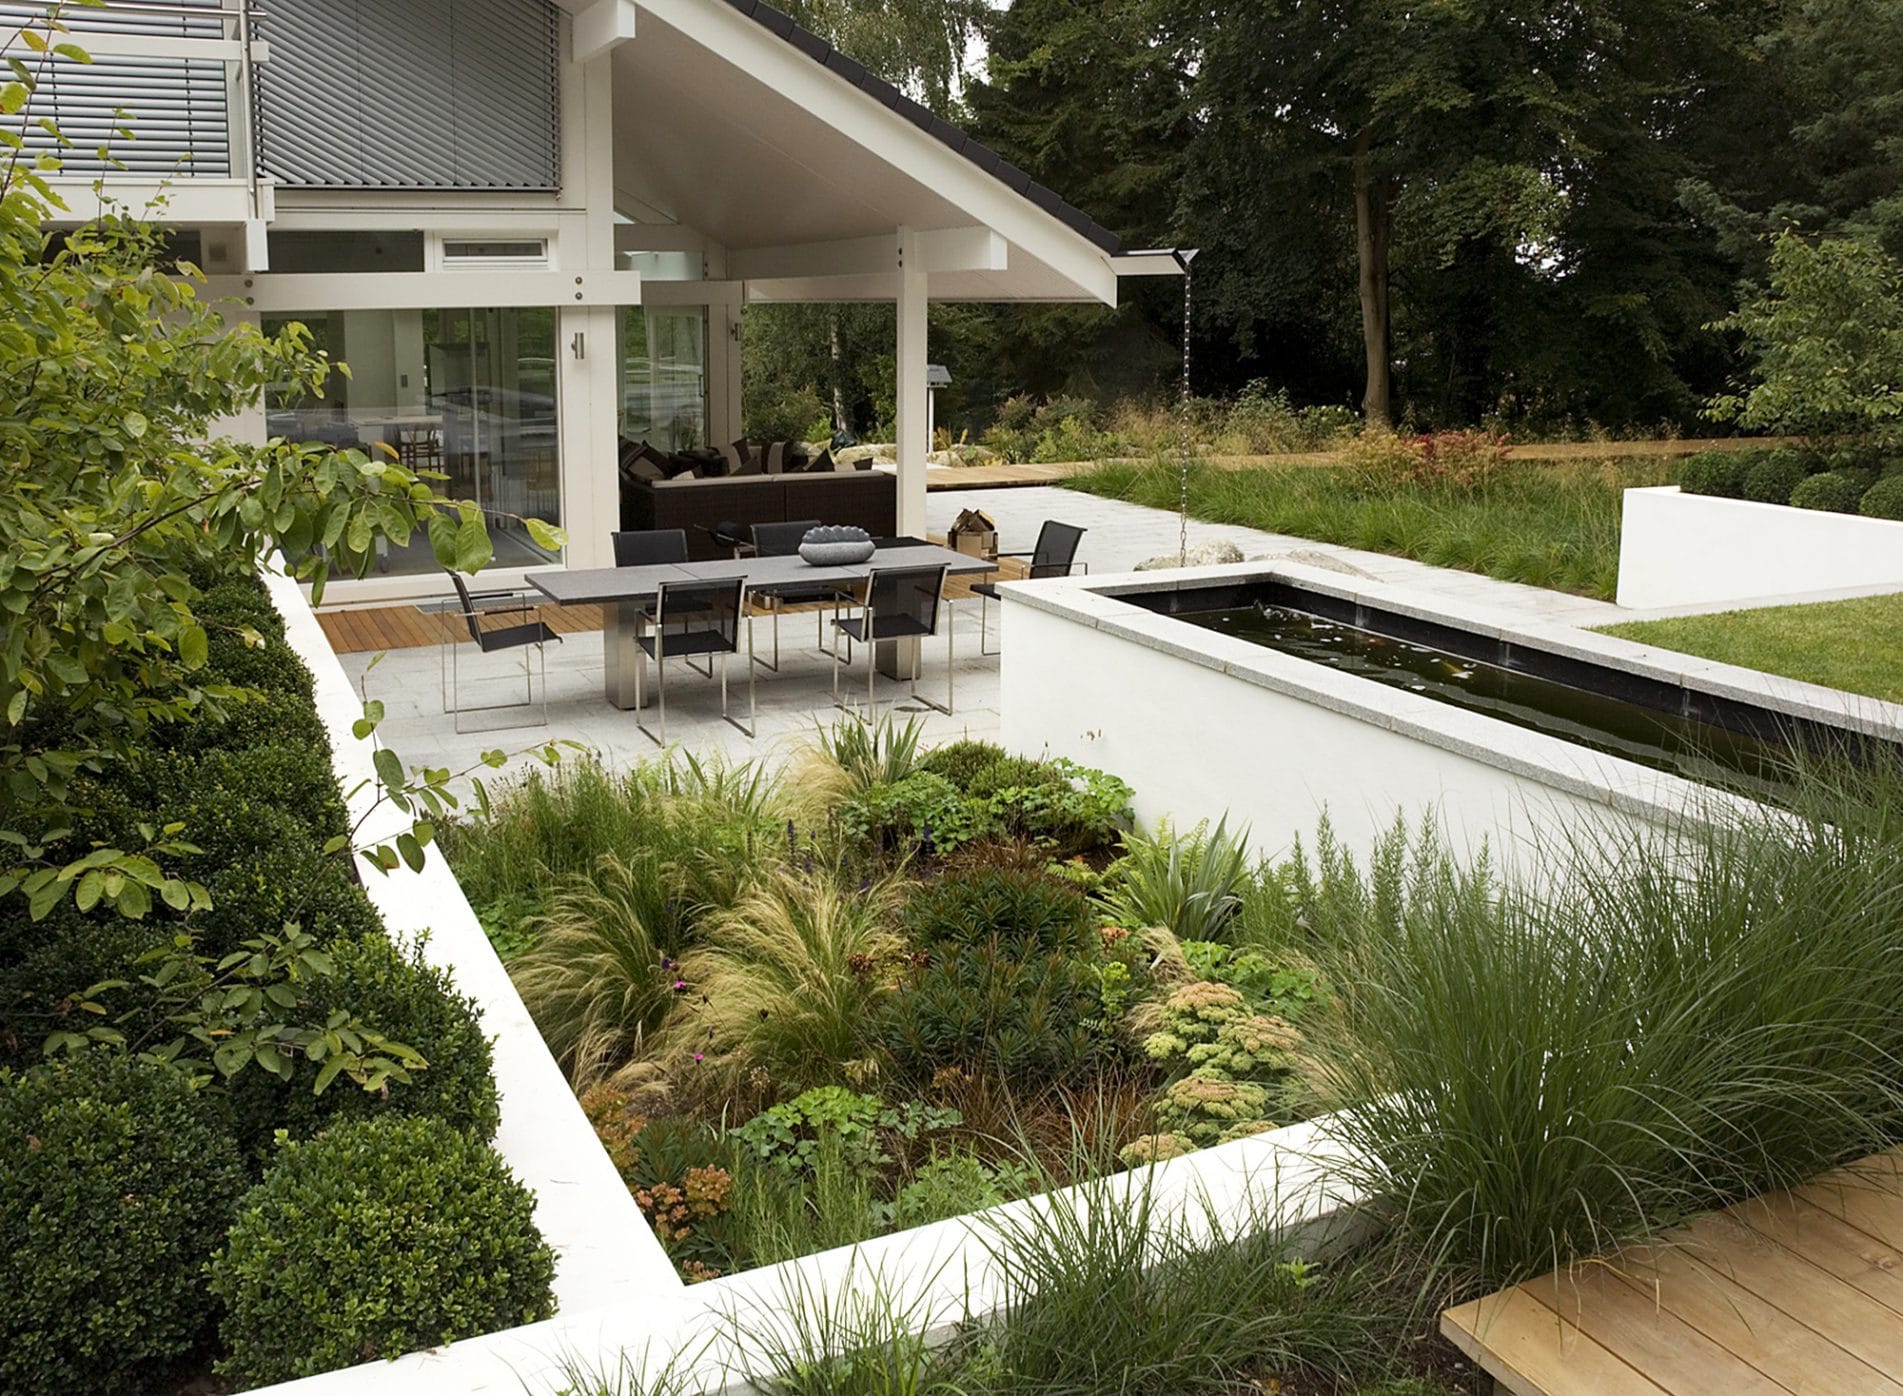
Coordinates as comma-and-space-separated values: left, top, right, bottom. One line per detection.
1441, 1289, 1667, 1396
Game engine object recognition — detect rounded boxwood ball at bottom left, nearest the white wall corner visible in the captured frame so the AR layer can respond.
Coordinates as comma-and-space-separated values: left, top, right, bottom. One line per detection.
211, 1118, 556, 1385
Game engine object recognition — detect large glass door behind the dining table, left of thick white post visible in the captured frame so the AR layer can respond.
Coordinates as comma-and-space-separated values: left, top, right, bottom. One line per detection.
265, 306, 561, 574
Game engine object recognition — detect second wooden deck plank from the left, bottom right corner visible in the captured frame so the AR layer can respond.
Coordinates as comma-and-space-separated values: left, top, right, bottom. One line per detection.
1520, 1263, 1789, 1396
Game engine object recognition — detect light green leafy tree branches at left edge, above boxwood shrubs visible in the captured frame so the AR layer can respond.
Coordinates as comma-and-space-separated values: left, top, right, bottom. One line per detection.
0, 21, 559, 917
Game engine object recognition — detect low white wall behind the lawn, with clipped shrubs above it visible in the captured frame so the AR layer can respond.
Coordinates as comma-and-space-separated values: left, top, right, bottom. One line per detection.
1618, 485, 1903, 609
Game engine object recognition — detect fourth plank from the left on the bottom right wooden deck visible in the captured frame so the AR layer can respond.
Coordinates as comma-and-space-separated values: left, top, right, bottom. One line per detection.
1677, 1213, 1903, 1373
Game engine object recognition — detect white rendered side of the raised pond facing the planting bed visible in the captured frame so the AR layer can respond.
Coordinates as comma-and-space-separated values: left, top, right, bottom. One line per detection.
999, 584, 1682, 860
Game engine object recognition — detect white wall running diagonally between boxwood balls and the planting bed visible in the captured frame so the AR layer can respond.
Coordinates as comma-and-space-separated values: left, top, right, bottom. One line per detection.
265, 574, 681, 1310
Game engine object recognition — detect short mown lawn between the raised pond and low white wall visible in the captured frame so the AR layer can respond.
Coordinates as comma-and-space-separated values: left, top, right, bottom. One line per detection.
1604, 593, 1903, 702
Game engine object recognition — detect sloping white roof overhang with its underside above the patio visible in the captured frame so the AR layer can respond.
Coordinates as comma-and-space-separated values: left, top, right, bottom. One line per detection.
613, 0, 1161, 304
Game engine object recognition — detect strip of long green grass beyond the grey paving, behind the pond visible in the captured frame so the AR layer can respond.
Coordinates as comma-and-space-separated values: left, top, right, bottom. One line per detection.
1064, 456, 1677, 601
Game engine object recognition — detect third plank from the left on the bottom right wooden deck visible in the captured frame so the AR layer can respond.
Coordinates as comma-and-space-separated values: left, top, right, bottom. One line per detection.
1602, 1246, 1903, 1396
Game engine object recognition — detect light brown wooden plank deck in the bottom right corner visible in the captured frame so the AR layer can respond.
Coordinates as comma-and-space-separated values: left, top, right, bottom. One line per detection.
1441, 1149, 1903, 1396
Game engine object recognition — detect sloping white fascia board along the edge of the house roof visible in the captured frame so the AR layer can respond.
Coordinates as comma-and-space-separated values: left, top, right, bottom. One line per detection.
641, 0, 1117, 306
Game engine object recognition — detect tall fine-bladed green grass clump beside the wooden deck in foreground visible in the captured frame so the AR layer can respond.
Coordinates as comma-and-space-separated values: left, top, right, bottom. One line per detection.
1309, 768, 1903, 1297
